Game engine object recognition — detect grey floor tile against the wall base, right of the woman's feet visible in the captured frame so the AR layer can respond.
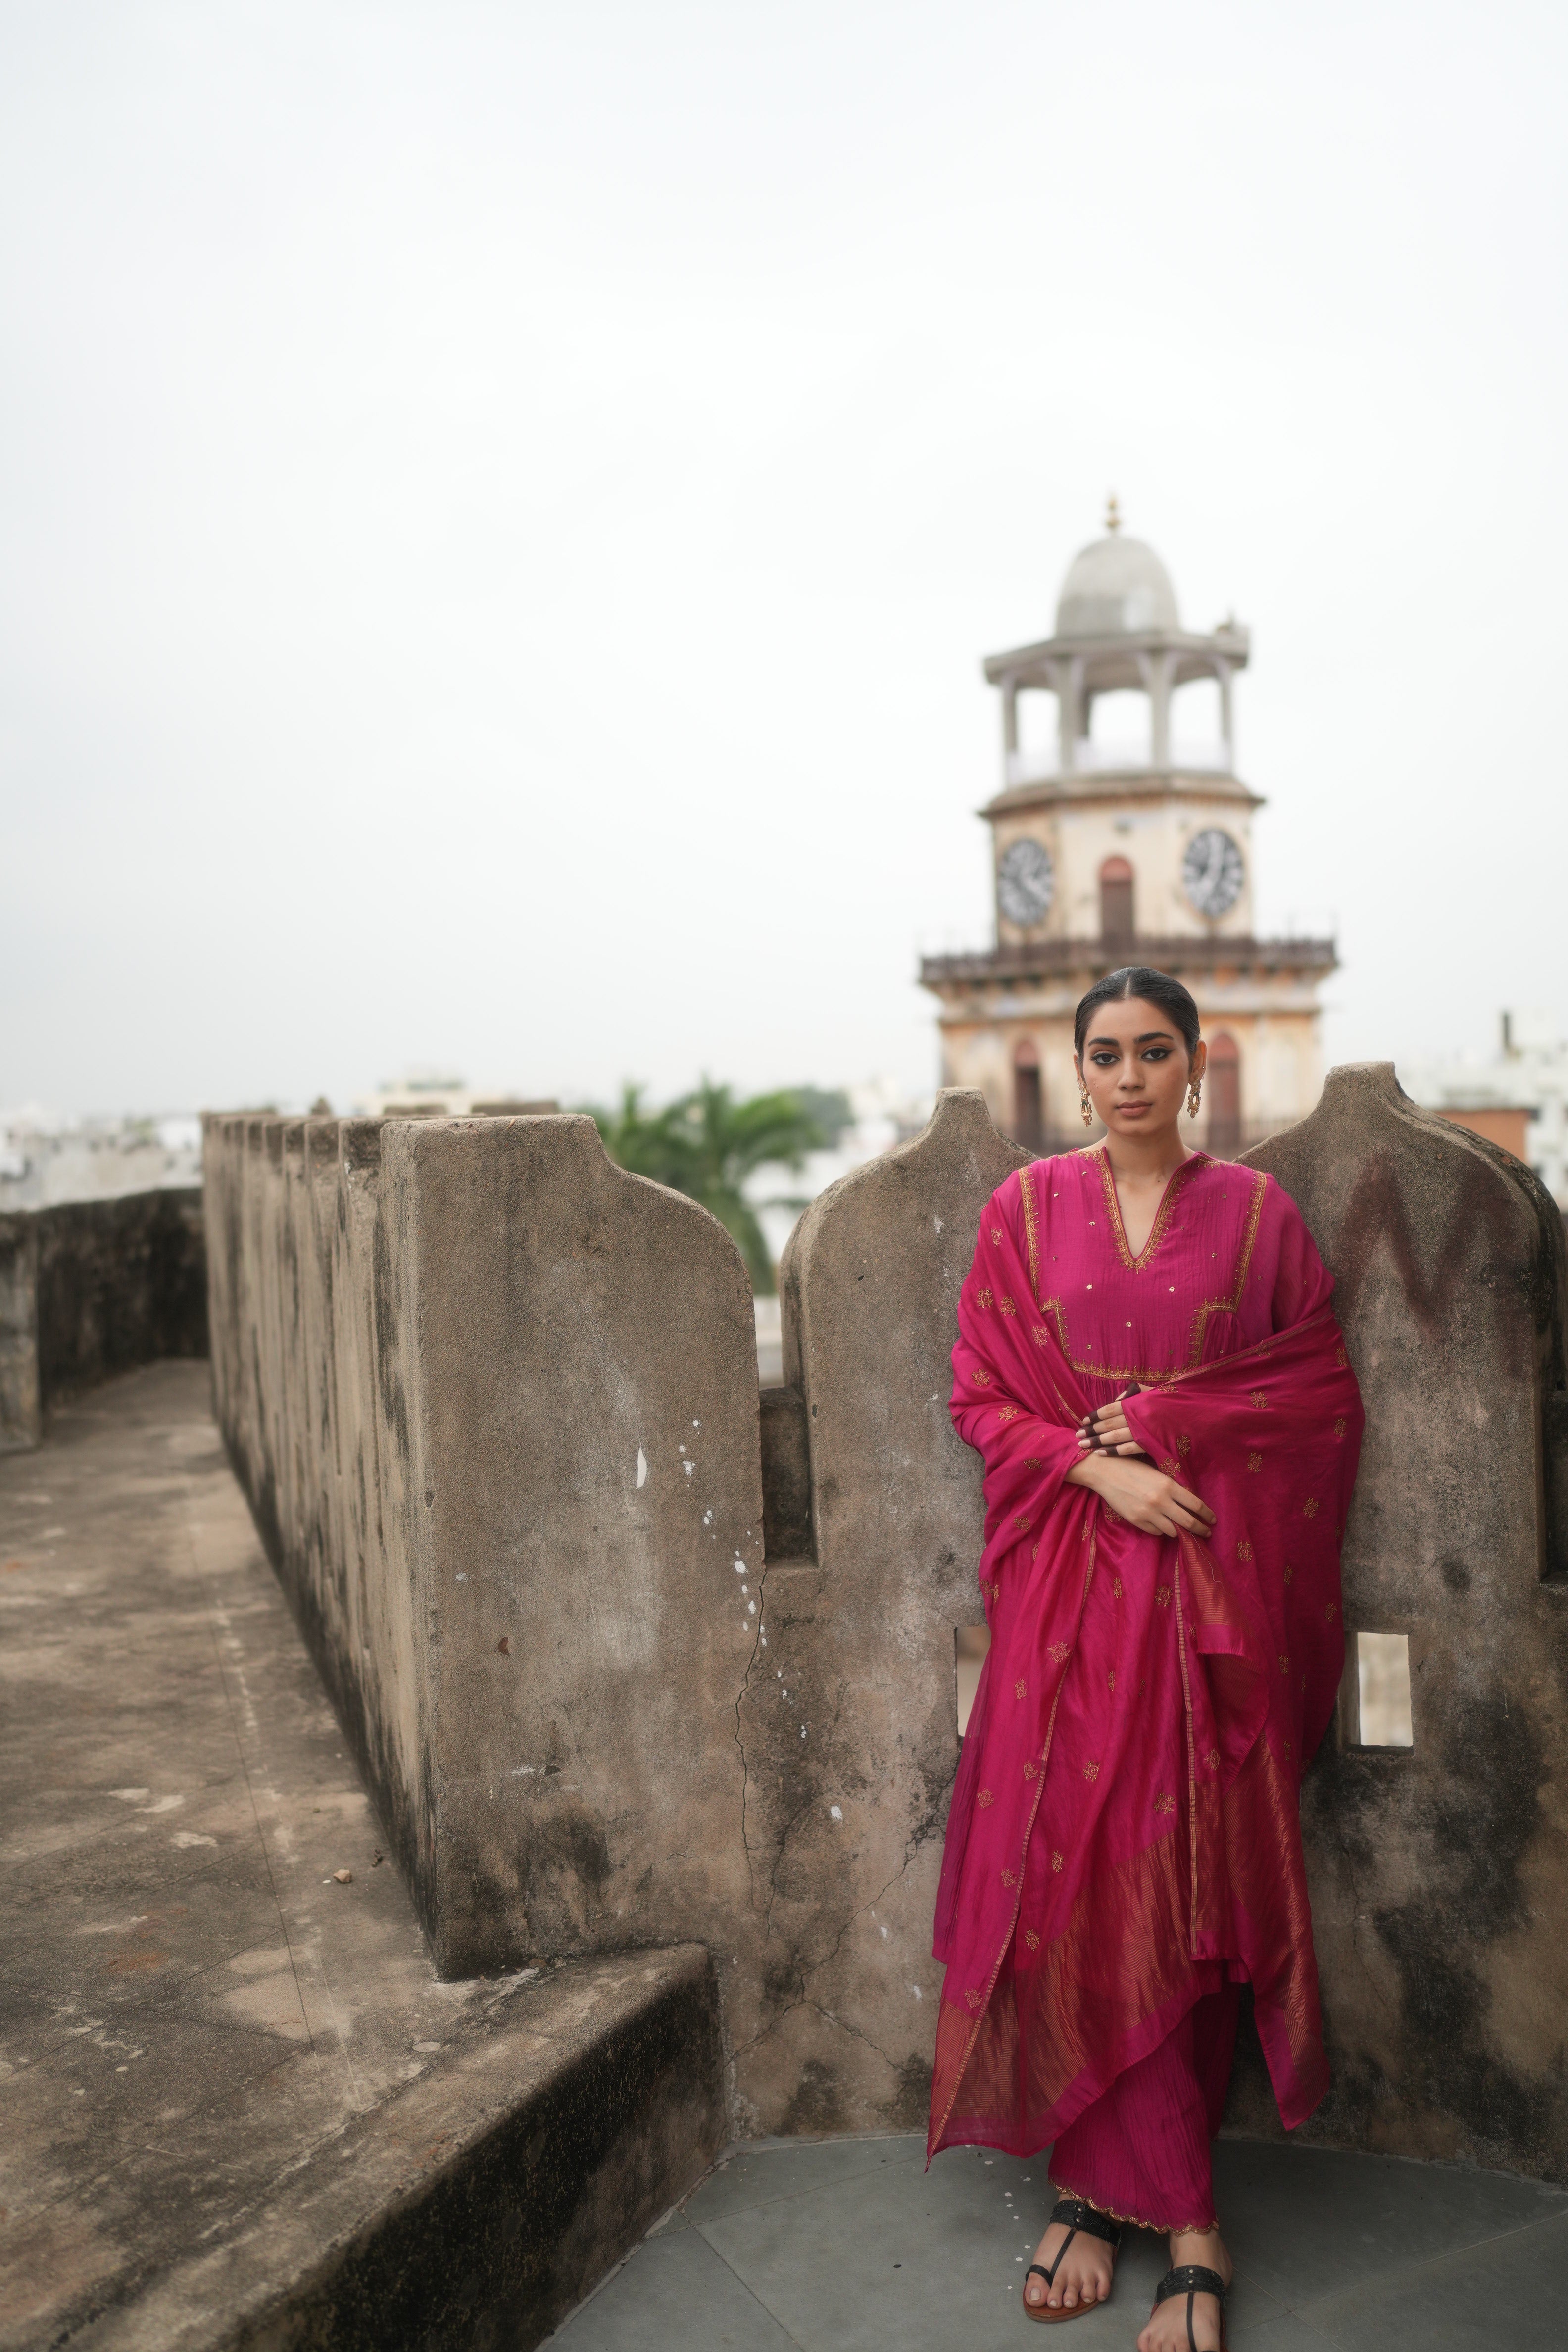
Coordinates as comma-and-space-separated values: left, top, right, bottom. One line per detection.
1216, 2140, 1568, 2309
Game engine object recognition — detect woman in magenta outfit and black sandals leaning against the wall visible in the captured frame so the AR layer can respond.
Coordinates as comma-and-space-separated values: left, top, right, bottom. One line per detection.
931, 967, 1361, 2352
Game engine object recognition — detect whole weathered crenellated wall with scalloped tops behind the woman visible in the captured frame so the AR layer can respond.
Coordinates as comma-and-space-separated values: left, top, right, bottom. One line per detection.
207, 1070, 1568, 2176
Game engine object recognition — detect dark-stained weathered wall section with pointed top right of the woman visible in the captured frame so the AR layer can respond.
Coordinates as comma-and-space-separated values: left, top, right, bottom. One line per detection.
1232, 1063, 1568, 2180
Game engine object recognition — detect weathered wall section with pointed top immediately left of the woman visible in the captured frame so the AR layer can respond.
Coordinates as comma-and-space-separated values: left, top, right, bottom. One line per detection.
738, 1091, 1025, 2131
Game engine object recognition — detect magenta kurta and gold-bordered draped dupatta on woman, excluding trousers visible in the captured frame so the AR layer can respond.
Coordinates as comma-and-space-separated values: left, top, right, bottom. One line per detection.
929, 1152, 1361, 2155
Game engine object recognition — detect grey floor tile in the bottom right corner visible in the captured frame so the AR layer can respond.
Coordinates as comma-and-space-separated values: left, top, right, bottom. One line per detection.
1302, 2213, 1568, 2352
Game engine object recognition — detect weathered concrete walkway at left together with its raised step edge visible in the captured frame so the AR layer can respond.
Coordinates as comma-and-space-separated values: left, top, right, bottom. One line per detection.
0, 1364, 724, 2352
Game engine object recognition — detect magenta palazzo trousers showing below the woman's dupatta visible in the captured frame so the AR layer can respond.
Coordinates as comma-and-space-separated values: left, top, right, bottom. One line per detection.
1051, 1985, 1239, 2230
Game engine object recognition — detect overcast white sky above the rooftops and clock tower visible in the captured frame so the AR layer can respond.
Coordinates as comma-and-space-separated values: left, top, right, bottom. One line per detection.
0, 0, 1568, 1110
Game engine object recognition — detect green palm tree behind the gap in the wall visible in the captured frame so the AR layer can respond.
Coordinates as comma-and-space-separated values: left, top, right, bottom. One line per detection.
592, 1077, 828, 1294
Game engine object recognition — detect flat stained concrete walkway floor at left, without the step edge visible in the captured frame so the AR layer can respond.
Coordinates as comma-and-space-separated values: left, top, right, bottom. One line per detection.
0, 1362, 531, 2347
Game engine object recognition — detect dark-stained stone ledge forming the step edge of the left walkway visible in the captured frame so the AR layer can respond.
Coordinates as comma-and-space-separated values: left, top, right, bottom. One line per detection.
60, 1945, 727, 2352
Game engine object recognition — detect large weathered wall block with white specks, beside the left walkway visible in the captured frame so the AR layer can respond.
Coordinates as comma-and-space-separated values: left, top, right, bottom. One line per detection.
207, 1117, 780, 2013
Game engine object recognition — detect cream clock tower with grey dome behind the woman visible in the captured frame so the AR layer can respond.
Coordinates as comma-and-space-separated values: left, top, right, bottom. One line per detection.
919, 498, 1335, 1155
